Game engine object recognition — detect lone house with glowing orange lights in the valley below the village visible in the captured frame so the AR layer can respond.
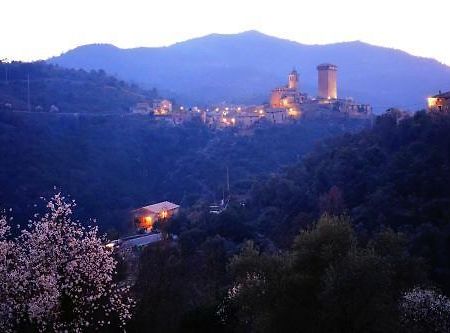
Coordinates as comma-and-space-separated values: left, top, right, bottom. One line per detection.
132, 201, 180, 232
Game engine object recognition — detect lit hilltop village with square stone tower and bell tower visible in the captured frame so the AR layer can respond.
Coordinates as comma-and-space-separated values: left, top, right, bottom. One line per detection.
131, 64, 372, 128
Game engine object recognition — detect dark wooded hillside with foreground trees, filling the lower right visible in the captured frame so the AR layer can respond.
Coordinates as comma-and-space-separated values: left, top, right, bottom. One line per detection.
129, 111, 450, 332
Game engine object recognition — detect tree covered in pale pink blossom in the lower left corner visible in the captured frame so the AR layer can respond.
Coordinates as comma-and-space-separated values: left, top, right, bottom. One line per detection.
0, 194, 133, 332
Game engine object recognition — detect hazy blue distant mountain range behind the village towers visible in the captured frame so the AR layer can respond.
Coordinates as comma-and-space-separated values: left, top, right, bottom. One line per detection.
49, 31, 450, 110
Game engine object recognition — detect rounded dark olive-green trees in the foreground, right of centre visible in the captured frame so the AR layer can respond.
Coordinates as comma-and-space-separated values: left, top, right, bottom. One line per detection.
225, 215, 424, 332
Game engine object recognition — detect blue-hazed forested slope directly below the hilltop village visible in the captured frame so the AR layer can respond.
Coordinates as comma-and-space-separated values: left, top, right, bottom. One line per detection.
0, 111, 369, 231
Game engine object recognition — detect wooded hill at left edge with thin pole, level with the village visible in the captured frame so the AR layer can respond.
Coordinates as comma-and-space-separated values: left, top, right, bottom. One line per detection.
0, 61, 157, 113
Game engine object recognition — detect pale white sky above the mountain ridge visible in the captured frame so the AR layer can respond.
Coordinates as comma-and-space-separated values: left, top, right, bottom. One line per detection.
0, 0, 450, 65
